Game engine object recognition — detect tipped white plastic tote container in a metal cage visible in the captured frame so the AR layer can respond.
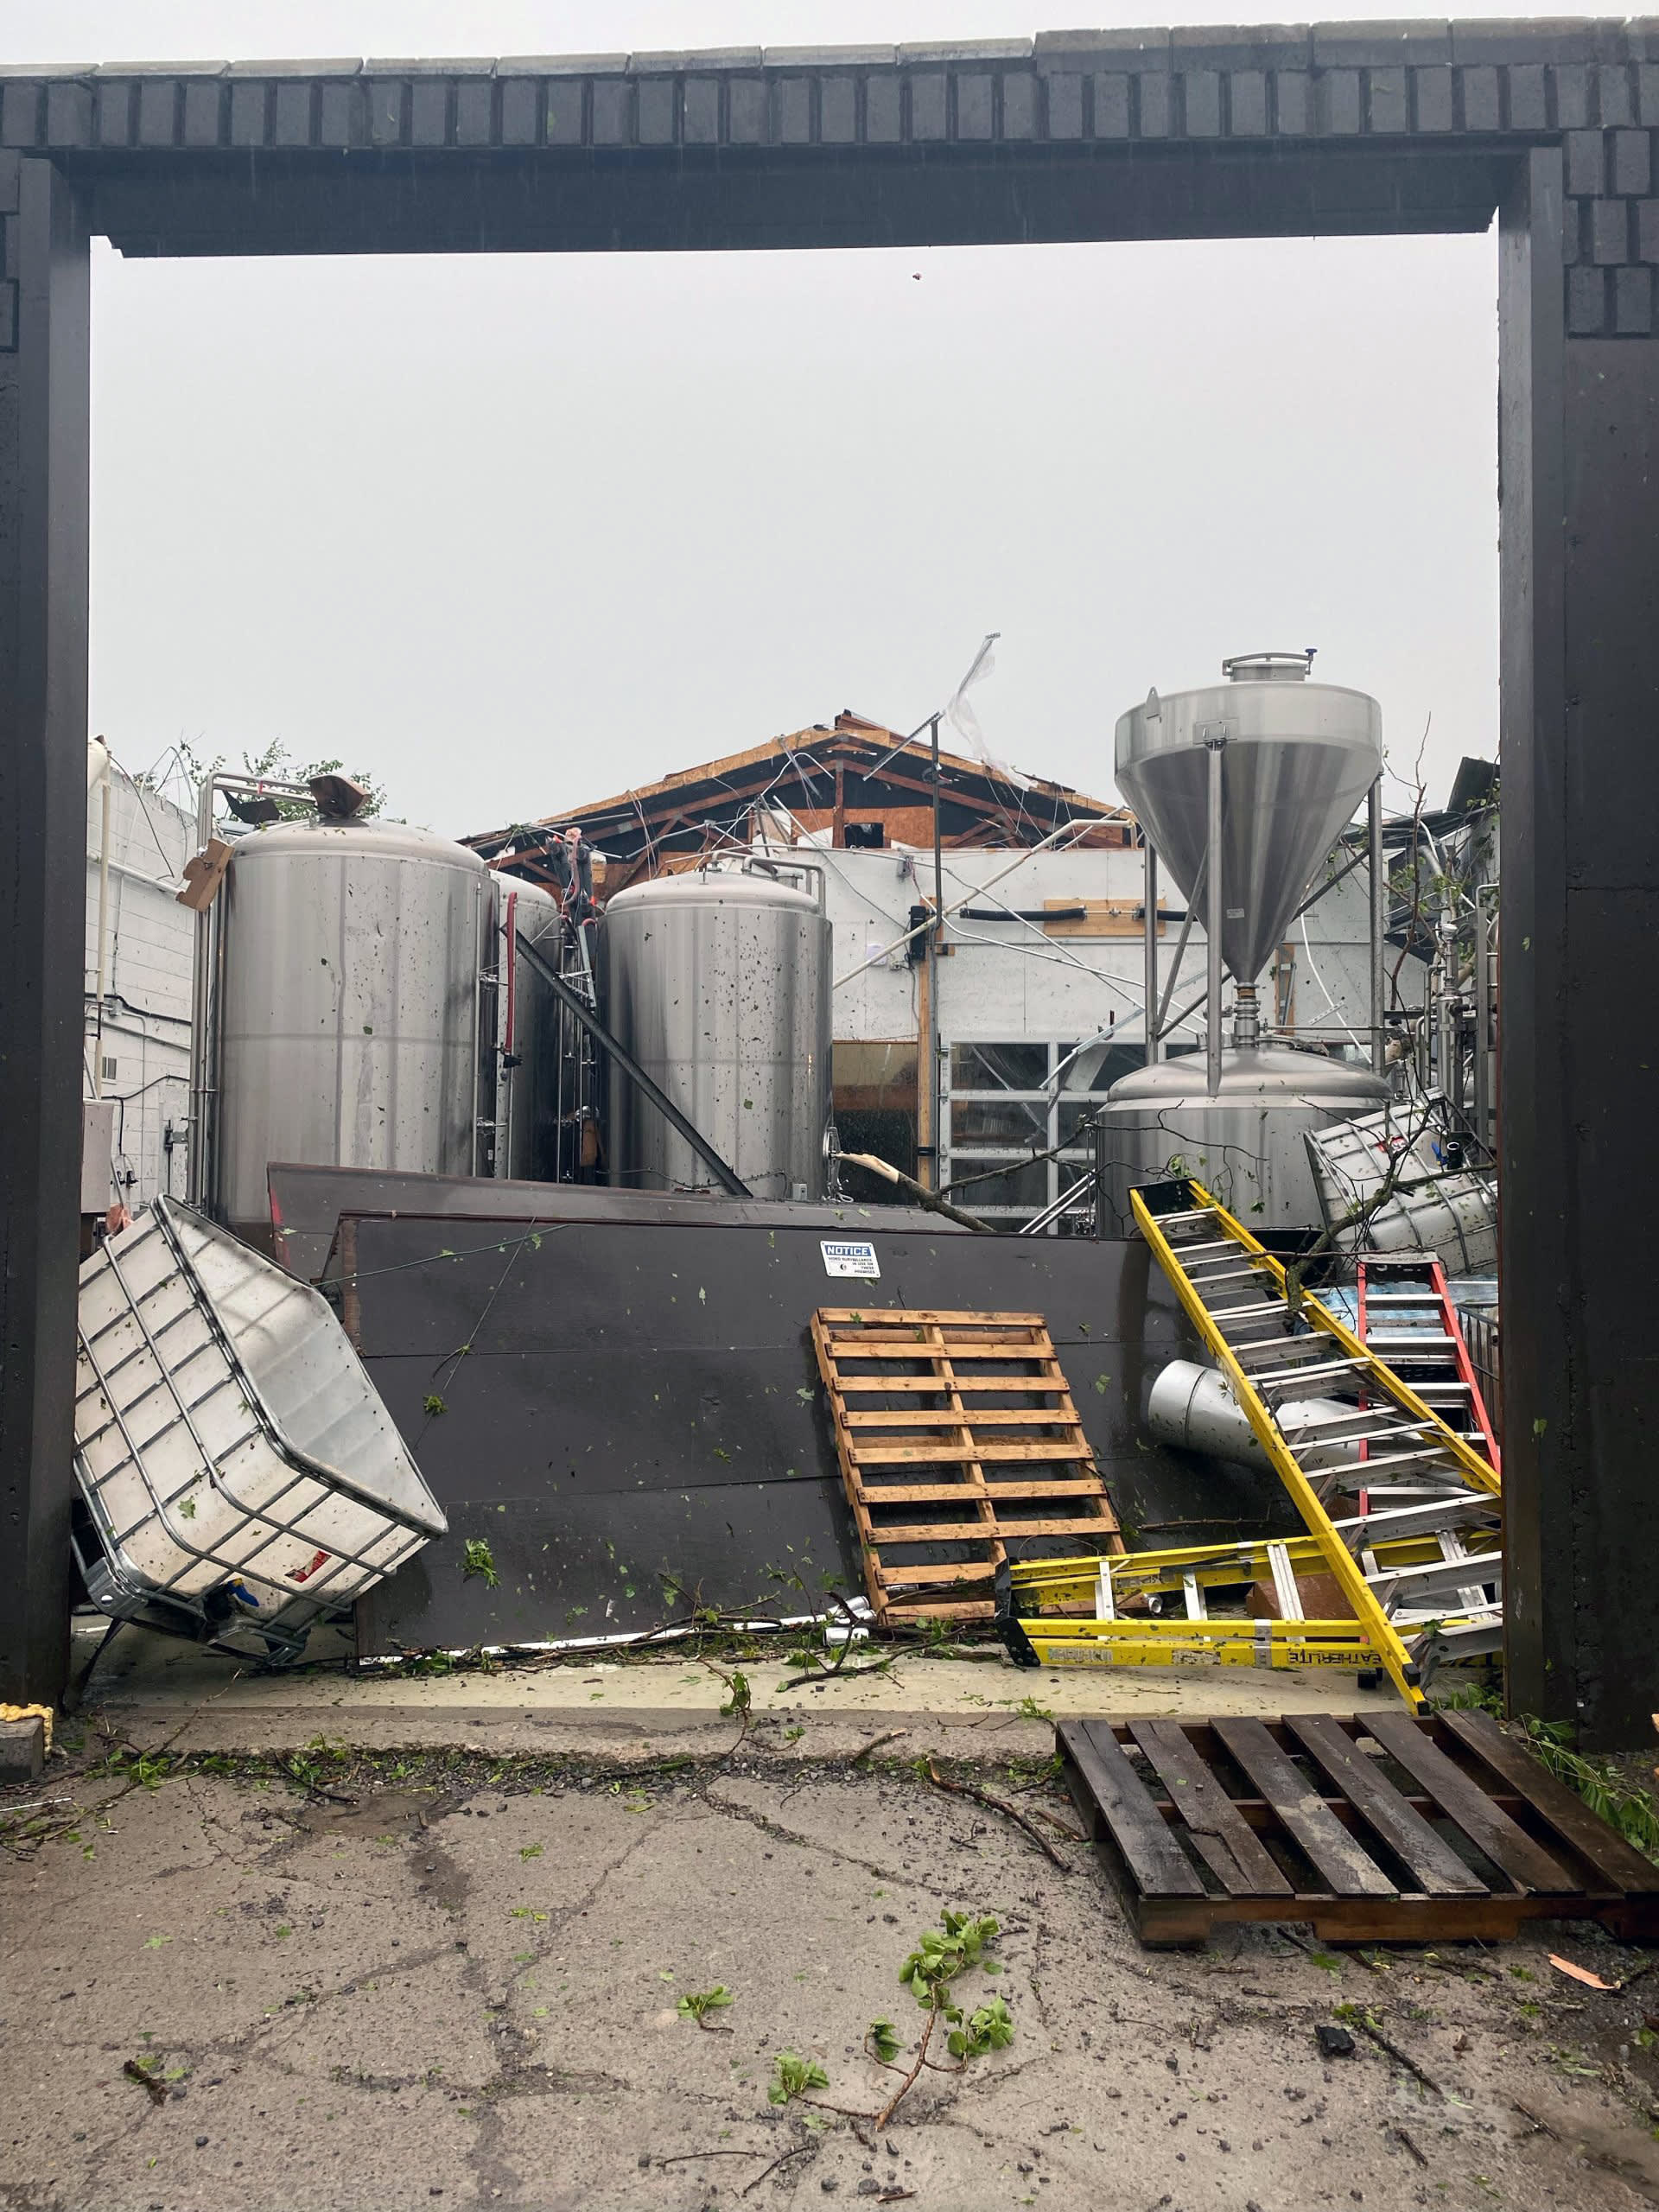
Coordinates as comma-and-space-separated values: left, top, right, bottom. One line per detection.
75, 1199, 447, 1659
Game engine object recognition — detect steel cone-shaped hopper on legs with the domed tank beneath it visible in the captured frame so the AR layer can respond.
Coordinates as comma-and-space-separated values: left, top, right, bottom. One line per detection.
1102, 652, 1389, 1228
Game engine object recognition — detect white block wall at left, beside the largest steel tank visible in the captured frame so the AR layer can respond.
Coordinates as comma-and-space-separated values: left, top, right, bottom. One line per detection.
82, 767, 197, 1208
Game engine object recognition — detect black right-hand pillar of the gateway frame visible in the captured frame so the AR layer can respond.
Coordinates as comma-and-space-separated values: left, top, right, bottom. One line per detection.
1500, 149, 1659, 1747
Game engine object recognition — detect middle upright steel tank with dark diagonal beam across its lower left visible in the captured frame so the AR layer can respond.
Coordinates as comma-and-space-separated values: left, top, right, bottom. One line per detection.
601, 865, 830, 1199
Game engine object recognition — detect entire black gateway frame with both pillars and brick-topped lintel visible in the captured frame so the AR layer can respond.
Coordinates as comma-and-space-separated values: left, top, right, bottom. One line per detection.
0, 22, 1659, 1743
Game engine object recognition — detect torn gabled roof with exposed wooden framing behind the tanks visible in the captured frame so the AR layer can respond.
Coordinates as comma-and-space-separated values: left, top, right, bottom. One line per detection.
467, 712, 1137, 892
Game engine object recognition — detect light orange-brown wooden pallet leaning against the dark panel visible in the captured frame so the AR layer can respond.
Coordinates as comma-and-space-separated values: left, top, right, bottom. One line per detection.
812, 1305, 1123, 1621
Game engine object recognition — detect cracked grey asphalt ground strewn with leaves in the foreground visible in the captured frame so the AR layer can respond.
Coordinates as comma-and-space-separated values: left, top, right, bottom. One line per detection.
0, 1745, 1659, 2212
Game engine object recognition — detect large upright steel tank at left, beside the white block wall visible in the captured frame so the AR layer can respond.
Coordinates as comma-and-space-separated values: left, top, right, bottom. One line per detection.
210, 818, 493, 1241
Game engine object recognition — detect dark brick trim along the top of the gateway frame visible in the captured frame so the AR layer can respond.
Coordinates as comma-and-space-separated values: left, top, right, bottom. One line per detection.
0, 17, 1659, 347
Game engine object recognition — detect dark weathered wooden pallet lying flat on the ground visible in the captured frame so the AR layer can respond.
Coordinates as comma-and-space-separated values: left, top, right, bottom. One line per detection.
1055, 1712, 1659, 1947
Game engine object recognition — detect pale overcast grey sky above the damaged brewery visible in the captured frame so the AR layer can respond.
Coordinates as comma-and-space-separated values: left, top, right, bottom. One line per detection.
0, 0, 1541, 832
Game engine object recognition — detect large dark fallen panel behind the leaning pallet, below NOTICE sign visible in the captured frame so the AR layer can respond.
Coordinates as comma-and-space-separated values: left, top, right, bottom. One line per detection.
339, 1219, 1289, 1652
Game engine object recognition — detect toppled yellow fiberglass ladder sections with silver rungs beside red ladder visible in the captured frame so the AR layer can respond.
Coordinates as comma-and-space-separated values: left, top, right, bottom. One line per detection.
998, 1181, 1502, 1707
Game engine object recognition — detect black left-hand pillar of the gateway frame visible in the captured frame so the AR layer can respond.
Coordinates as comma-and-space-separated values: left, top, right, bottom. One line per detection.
0, 153, 91, 1703
